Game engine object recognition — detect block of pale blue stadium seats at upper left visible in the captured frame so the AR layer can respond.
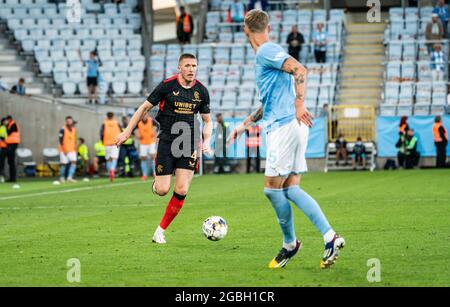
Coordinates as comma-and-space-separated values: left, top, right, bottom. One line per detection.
0, 0, 145, 96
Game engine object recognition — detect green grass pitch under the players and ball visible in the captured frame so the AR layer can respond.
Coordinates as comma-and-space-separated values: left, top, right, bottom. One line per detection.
0, 170, 450, 286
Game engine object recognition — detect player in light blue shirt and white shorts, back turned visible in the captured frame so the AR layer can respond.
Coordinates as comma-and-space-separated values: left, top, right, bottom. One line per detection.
229, 10, 345, 269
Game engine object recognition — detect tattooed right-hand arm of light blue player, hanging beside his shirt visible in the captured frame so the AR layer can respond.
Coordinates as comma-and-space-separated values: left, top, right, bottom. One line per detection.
282, 57, 312, 127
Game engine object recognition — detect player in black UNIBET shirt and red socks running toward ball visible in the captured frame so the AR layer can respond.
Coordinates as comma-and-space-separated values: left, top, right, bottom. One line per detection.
116, 53, 212, 244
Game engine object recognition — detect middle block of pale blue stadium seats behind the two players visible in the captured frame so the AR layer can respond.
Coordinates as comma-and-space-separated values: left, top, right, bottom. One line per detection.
149, 0, 345, 116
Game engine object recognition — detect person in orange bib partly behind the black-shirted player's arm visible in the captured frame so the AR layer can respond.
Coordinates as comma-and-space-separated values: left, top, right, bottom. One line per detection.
138, 114, 156, 181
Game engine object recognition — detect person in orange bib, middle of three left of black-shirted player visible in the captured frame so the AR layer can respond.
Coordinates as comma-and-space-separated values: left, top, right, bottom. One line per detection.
100, 112, 122, 182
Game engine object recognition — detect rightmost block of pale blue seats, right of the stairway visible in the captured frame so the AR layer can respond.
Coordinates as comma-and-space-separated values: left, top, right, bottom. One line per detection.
380, 7, 449, 116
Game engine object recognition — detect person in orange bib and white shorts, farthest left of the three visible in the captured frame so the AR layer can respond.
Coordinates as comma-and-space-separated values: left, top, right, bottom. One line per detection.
59, 116, 77, 183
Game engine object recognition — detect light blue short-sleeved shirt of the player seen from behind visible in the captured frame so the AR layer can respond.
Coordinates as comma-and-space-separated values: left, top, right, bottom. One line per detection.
255, 42, 296, 131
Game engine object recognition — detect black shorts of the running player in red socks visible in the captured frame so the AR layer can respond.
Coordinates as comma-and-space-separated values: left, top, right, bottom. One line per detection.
155, 140, 198, 176
